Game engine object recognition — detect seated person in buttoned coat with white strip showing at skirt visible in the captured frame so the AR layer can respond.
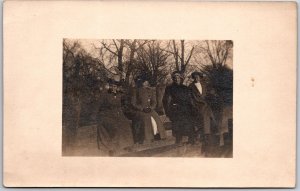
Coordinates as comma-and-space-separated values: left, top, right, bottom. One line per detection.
131, 77, 166, 143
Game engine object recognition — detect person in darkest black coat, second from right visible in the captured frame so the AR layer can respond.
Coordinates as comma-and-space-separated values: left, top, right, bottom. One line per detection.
163, 71, 194, 144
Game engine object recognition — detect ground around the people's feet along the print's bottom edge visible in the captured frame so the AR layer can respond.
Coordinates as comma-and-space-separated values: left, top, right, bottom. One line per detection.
63, 125, 232, 158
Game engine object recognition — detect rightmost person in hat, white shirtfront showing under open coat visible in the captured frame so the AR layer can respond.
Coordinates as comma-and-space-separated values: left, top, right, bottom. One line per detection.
189, 72, 216, 146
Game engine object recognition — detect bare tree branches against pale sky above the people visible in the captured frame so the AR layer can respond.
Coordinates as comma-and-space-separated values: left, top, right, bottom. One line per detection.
63, 39, 233, 89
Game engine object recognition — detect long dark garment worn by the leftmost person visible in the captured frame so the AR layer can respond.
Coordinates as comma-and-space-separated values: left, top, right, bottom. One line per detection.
97, 92, 133, 155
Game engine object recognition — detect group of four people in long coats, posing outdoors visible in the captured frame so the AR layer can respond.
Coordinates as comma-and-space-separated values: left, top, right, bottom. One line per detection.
97, 71, 220, 155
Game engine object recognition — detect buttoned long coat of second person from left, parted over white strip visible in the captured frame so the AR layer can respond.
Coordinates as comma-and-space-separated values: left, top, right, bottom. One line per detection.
131, 87, 166, 141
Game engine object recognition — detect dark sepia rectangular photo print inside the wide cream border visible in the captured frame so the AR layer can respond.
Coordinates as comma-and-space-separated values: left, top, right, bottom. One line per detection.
62, 38, 234, 158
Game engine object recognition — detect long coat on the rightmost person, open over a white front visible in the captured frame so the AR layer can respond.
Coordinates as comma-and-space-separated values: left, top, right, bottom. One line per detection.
189, 83, 215, 134
